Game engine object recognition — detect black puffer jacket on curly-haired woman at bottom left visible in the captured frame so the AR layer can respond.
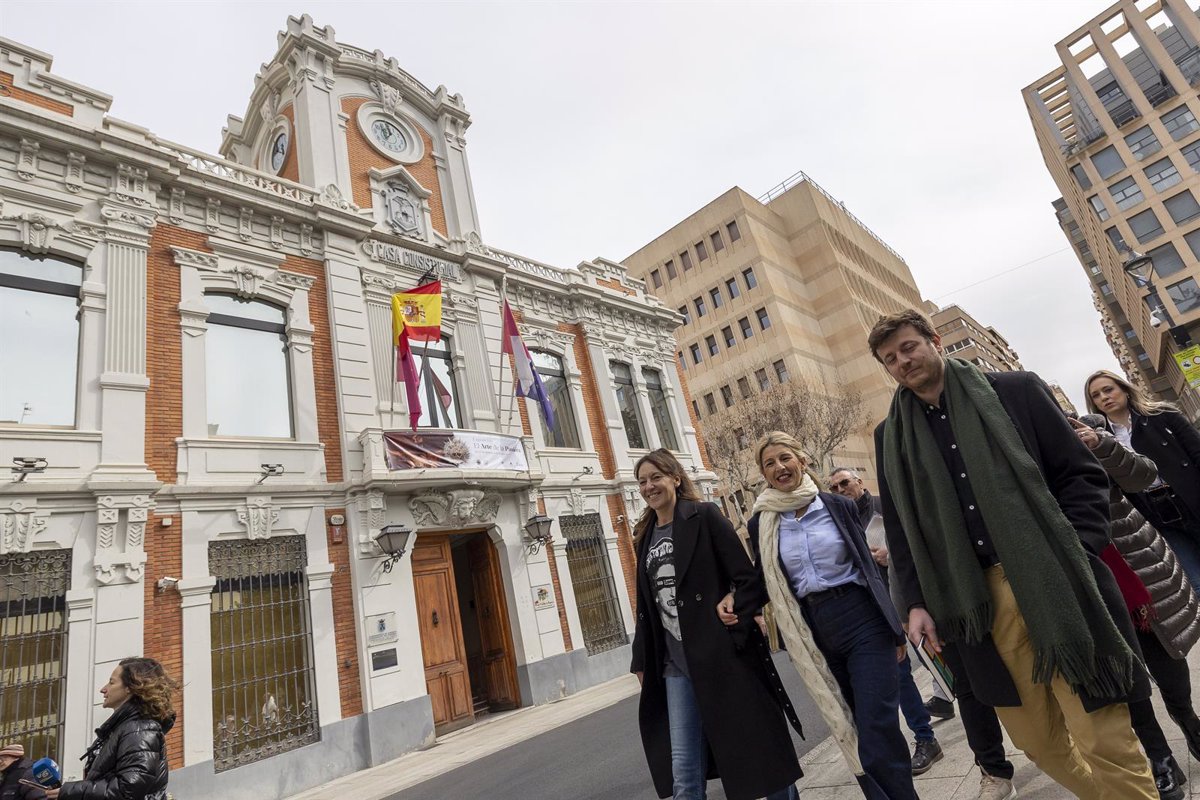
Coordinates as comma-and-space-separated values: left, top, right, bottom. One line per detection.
59, 699, 175, 800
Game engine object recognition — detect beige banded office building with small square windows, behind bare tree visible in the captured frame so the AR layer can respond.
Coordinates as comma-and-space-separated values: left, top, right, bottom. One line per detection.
624, 173, 922, 489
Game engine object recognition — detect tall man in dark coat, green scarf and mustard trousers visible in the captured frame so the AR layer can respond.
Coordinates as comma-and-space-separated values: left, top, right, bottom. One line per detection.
868, 309, 1158, 800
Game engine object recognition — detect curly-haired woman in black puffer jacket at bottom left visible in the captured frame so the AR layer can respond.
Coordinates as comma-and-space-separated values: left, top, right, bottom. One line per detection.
46, 658, 178, 800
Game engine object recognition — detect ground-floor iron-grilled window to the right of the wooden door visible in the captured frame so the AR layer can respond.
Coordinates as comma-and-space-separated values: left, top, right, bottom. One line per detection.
558, 513, 629, 655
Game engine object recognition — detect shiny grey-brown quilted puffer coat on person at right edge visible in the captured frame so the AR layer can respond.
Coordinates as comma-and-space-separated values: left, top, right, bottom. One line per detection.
1092, 431, 1200, 658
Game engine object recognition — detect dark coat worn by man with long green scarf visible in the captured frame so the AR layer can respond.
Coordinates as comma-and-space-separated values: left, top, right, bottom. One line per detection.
875, 372, 1150, 711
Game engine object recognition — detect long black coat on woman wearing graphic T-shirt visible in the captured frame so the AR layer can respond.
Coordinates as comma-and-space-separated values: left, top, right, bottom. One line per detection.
630, 500, 804, 800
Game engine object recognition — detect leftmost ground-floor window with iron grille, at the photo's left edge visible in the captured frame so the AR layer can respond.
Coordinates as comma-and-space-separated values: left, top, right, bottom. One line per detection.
0, 551, 71, 762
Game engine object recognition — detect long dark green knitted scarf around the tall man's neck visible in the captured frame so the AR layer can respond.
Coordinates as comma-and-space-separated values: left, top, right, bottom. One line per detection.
883, 359, 1133, 697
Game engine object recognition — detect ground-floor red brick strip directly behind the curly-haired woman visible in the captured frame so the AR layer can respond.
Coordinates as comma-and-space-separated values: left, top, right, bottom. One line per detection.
142, 515, 185, 770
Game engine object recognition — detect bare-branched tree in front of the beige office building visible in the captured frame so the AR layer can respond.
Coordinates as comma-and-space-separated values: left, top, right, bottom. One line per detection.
701, 369, 866, 524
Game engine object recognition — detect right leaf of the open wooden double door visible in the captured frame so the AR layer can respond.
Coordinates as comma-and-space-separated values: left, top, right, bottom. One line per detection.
467, 534, 521, 709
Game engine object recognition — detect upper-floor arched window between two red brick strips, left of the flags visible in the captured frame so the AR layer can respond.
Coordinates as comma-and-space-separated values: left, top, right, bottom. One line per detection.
204, 294, 292, 439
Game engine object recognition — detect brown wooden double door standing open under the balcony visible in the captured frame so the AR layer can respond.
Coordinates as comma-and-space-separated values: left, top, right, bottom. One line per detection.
413, 533, 521, 734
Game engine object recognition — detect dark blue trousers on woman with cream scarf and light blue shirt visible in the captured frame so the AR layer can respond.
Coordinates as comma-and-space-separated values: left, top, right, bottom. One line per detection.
800, 584, 917, 800
